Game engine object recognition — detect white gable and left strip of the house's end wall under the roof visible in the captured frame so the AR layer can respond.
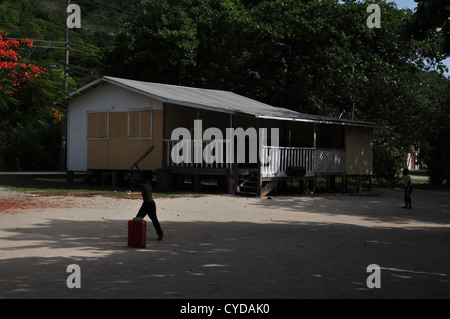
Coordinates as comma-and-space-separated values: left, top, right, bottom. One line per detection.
67, 83, 163, 171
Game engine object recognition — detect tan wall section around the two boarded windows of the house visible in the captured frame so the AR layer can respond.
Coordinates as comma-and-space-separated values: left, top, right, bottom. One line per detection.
88, 110, 163, 170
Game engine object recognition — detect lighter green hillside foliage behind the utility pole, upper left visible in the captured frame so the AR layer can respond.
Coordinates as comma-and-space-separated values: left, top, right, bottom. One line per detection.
0, 0, 140, 89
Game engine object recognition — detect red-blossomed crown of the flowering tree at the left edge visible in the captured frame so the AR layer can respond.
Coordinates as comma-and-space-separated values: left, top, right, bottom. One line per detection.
0, 31, 62, 123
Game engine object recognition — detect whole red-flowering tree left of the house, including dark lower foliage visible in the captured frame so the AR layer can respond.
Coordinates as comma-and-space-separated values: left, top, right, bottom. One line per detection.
0, 31, 64, 170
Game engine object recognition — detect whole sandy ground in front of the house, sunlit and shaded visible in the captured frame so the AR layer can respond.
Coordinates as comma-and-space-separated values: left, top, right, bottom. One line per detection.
0, 189, 450, 299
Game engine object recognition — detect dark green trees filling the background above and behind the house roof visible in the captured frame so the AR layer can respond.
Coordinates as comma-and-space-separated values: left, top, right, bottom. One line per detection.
0, 0, 450, 182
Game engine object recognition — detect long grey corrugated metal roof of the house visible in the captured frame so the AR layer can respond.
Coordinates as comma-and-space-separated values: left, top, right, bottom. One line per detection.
71, 76, 380, 127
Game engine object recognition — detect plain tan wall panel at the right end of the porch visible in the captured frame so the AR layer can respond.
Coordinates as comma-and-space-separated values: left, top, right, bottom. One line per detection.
345, 126, 373, 175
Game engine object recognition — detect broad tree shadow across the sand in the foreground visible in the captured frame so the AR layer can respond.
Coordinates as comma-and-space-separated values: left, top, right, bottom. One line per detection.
0, 200, 450, 298
